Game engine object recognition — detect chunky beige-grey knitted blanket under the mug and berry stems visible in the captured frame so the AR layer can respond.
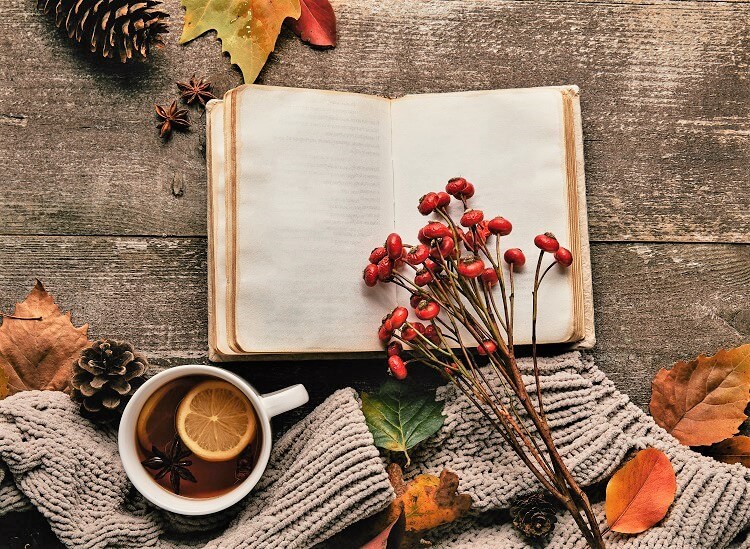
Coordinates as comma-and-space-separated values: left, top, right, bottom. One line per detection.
0, 353, 750, 548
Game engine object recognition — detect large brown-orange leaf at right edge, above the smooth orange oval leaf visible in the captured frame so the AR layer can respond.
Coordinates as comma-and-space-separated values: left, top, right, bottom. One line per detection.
649, 344, 750, 446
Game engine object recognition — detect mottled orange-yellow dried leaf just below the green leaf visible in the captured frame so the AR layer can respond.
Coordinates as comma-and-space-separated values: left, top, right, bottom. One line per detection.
400, 469, 472, 532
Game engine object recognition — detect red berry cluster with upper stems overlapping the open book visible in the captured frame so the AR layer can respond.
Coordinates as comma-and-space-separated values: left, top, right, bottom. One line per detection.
362, 177, 573, 379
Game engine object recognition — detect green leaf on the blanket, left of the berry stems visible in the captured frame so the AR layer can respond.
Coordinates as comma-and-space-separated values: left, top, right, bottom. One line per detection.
362, 380, 445, 466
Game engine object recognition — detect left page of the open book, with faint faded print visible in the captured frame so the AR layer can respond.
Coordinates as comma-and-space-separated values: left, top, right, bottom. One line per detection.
233, 86, 394, 353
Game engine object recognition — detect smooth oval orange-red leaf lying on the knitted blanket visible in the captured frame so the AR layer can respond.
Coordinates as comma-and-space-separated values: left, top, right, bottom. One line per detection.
604, 448, 677, 534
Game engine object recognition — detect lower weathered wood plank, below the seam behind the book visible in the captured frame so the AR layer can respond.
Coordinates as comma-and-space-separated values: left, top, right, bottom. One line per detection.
0, 237, 750, 412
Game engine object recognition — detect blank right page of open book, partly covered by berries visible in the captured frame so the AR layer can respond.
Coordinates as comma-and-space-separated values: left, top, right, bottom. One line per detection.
392, 88, 574, 344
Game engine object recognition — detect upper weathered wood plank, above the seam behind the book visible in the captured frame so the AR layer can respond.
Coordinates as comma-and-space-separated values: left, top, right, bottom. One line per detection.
0, 0, 750, 242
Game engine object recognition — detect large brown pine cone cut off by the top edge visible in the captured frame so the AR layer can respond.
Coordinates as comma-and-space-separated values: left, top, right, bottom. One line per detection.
37, 0, 169, 63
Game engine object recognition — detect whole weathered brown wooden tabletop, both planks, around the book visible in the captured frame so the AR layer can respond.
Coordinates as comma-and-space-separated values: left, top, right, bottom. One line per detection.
0, 0, 750, 547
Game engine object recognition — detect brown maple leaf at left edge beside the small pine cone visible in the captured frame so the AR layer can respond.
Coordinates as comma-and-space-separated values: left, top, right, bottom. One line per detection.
0, 280, 91, 395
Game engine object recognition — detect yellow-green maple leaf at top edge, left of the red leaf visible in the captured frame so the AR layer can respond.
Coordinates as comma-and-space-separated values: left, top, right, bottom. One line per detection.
180, 0, 301, 83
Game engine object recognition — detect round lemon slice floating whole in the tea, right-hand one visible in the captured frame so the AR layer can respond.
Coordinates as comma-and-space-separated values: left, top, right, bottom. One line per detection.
177, 380, 258, 461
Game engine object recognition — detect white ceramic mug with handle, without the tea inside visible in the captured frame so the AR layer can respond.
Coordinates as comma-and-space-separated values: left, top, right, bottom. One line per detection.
117, 364, 309, 515
